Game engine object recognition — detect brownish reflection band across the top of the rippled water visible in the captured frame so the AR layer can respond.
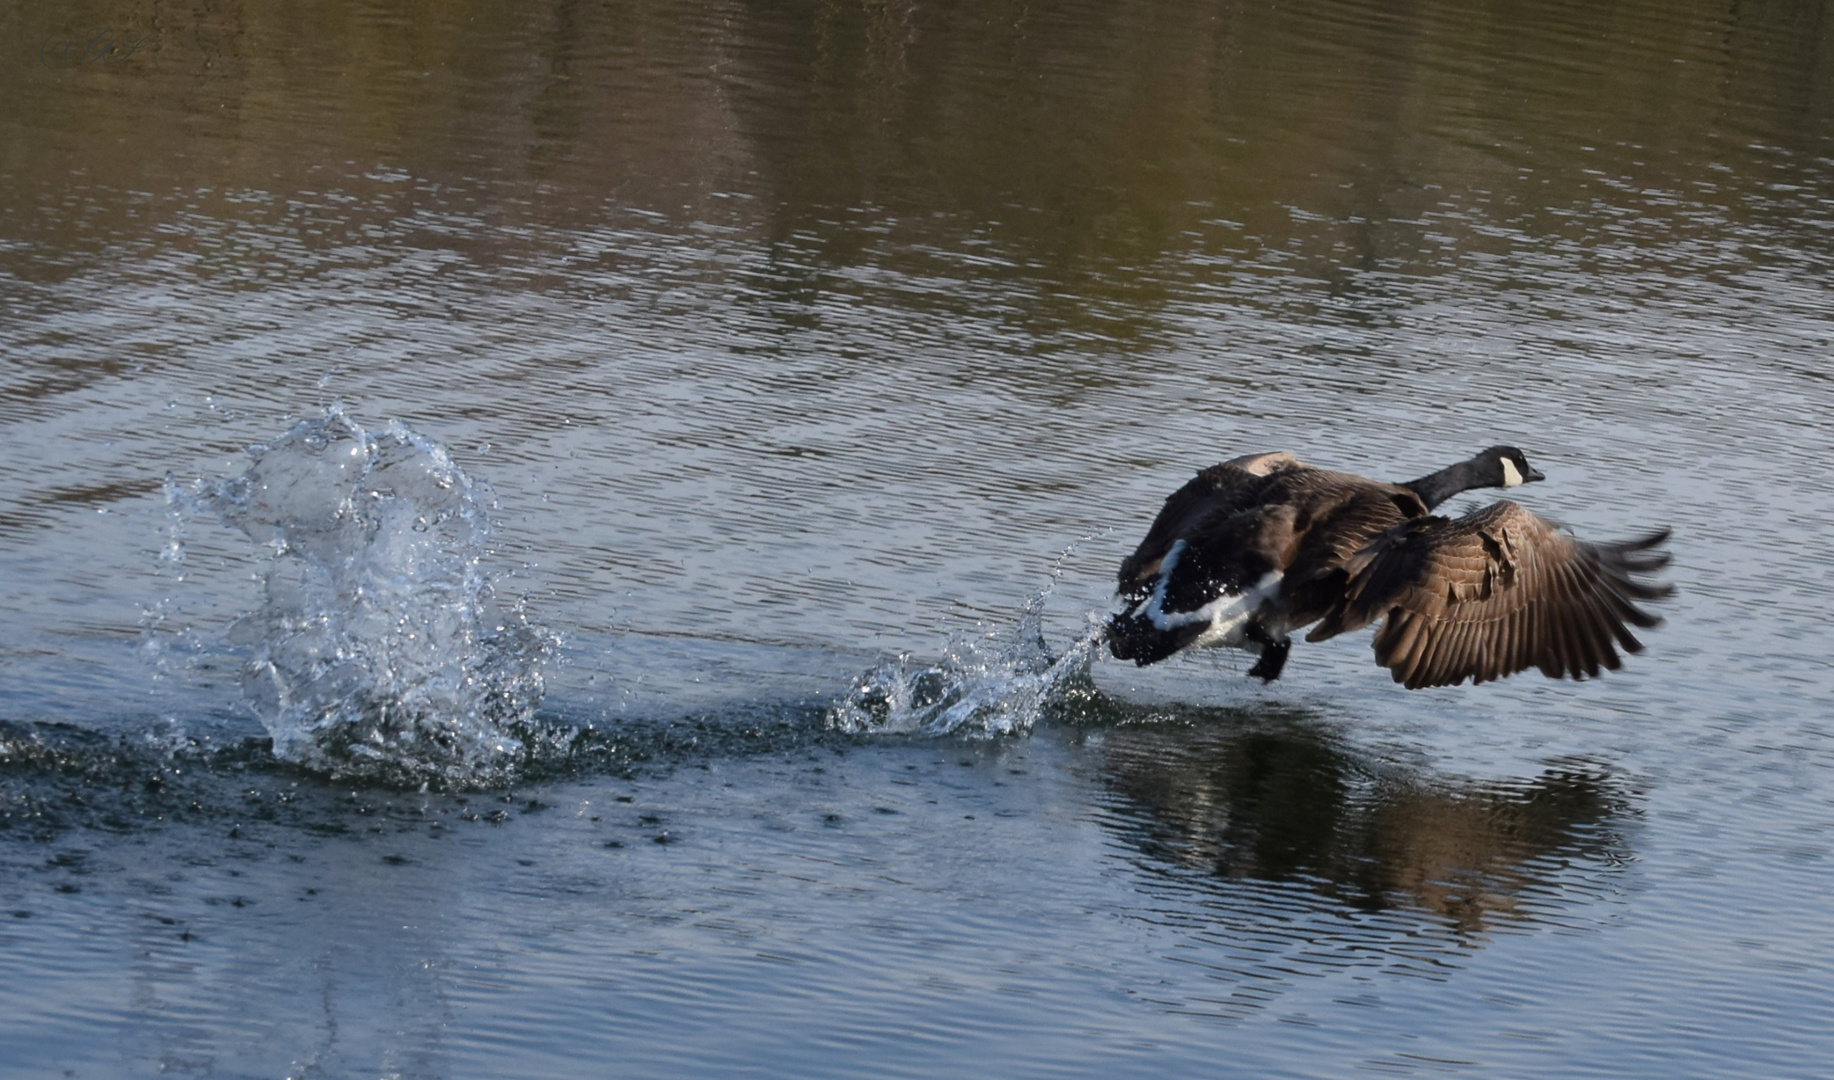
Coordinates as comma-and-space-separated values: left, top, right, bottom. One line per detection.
0, 0, 1834, 282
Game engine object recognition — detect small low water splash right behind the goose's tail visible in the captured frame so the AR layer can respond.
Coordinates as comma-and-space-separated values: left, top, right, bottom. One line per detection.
827, 561, 1102, 737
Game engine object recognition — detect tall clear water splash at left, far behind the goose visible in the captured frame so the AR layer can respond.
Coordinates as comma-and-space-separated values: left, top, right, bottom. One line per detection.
163, 405, 552, 785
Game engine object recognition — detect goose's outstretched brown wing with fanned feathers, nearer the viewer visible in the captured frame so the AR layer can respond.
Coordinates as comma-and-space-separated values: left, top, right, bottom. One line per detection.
1308, 501, 1673, 689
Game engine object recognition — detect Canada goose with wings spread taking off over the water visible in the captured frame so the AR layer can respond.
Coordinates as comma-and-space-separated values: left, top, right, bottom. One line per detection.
1108, 446, 1673, 689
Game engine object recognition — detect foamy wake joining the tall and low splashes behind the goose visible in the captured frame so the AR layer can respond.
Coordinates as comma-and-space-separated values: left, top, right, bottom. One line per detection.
135, 405, 1102, 788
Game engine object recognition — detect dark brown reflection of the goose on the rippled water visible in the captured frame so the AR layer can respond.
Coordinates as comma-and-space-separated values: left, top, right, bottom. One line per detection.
1084, 710, 1632, 935
